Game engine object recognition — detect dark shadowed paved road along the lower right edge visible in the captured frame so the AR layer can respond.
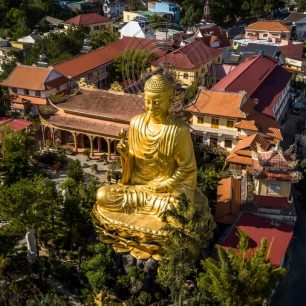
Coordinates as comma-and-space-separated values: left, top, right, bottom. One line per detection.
274, 186, 306, 306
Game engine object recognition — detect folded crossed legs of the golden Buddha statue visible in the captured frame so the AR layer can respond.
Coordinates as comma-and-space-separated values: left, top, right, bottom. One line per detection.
97, 184, 176, 215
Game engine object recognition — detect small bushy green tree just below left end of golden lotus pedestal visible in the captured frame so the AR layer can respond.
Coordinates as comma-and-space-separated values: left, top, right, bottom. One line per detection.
81, 243, 114, 293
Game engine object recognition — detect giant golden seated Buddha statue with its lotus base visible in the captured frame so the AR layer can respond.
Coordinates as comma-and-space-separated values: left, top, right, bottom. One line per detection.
93, 75, 210, 259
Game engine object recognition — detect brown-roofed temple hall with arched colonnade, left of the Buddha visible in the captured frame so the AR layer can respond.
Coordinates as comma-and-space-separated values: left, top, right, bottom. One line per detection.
40, 88, 144, 159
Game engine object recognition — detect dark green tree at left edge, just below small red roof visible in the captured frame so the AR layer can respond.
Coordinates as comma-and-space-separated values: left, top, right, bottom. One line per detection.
1, 131, 35, 184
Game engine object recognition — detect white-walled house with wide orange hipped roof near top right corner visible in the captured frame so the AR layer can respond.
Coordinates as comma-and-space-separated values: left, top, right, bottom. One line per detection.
245, 20, 291, 41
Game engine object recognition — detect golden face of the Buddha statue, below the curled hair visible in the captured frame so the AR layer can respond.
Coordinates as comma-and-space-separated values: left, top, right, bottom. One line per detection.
144, 92, 171, 119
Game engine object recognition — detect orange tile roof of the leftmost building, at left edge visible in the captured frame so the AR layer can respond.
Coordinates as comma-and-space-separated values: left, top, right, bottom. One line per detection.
0, 65, 52, 90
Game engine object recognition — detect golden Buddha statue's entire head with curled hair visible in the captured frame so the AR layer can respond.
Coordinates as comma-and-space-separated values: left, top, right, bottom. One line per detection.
144, 74, 173, 121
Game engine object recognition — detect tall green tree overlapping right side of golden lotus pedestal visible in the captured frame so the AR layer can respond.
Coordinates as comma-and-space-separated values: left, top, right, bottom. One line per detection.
157, 194, 213, 306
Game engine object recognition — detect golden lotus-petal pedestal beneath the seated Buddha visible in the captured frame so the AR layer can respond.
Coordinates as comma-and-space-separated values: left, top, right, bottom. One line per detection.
93, 204, 166, 260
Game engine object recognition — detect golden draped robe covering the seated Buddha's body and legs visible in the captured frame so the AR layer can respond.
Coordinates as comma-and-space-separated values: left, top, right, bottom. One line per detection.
97, 113, 196, 216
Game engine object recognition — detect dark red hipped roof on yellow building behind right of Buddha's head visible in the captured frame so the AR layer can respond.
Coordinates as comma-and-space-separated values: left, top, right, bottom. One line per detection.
152, 40, 222, 70
